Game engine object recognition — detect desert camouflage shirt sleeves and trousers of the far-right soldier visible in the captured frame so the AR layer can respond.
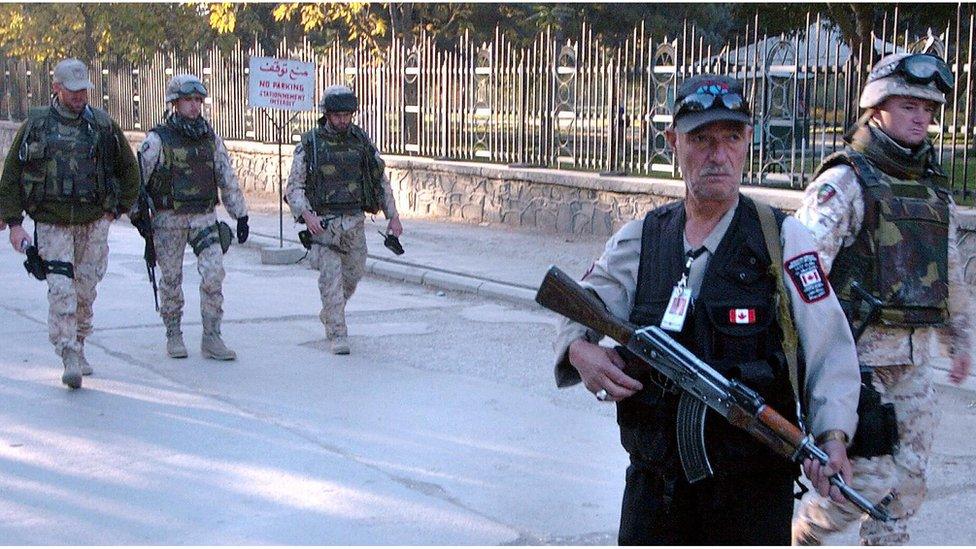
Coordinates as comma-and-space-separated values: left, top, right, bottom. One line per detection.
794, 159, 970, 545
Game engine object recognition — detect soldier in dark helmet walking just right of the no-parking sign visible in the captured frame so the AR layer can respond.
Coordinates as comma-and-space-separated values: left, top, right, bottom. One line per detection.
287, 86, 403, 355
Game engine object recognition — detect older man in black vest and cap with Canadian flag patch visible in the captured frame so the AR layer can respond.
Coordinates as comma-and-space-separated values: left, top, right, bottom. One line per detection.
555, 75, 858, 545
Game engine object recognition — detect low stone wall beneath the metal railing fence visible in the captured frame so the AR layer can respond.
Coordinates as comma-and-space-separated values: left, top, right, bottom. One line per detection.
0, 122, 976, 283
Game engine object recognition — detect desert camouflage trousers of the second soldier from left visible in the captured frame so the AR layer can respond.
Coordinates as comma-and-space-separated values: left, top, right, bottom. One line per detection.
153, 211, 225, 328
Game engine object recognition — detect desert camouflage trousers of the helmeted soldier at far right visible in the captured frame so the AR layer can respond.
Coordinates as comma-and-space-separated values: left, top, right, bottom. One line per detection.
793, 328, 945, 545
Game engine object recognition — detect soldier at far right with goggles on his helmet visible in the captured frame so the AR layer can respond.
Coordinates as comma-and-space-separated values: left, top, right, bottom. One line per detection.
793, 53, 970, 545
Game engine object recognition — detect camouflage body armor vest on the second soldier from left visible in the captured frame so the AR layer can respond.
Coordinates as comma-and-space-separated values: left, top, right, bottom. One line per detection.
149, 124, 219, 214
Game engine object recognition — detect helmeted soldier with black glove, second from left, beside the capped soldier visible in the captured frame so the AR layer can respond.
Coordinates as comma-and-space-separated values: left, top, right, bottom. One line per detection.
136, 74, 249, 360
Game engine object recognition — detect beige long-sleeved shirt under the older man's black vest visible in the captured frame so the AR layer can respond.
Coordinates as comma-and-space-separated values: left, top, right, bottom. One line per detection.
554, 199, 860, 437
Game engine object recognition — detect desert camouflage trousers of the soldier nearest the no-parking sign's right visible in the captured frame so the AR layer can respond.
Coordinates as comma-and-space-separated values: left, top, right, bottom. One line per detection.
309, 215, 366, 339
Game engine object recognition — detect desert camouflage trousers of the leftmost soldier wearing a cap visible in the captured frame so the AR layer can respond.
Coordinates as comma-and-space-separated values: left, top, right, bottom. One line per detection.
37, 218, 111, 356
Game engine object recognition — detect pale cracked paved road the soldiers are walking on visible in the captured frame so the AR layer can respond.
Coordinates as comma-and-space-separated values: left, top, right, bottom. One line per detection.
0, 218, 976, 545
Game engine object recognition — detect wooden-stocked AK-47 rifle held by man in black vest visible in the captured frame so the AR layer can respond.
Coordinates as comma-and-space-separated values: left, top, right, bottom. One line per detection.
535, 267, 889, 521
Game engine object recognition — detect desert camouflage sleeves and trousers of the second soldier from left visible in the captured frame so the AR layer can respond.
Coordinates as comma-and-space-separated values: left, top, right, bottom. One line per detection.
140, 132, 247, 333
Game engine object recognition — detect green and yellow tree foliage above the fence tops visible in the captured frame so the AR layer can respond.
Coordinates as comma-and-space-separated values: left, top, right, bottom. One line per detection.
0, 1, 971, 66
